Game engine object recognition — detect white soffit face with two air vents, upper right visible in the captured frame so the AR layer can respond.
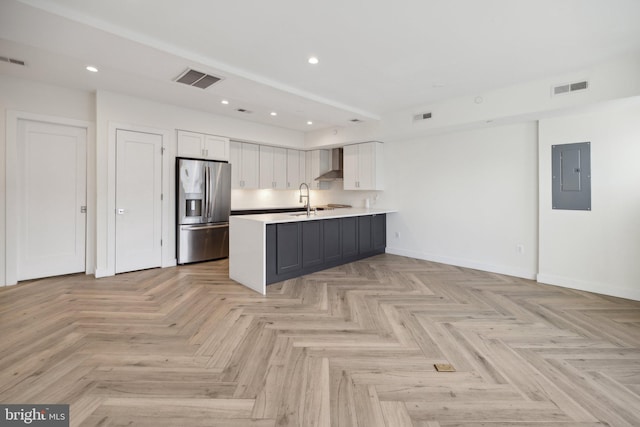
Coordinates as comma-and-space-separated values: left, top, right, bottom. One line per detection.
380, 52, 640, 141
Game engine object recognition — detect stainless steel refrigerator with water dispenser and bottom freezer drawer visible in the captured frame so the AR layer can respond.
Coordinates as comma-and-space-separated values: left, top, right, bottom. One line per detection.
176, 158, 231, 264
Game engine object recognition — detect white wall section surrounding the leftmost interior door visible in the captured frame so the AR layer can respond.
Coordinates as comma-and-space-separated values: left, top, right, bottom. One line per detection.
0, 75, 95, 286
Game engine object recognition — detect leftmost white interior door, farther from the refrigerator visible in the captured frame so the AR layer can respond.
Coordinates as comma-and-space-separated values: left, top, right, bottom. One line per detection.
17, 120, 87, 280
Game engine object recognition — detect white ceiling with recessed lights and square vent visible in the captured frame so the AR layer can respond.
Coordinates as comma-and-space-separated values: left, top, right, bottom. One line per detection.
0, 0, 640, 131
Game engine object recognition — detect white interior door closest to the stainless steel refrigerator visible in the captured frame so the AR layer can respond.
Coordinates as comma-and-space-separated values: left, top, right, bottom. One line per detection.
115, 130, 162, 273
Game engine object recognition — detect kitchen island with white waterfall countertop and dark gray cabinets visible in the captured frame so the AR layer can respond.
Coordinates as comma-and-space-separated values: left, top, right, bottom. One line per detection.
229, 208, 396, 295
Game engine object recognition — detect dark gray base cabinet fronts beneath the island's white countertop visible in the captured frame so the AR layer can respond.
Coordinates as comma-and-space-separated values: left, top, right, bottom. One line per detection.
266, 214, 387, 284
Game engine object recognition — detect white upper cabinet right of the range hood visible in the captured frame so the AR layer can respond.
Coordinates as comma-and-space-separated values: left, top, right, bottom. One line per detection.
343, 142, 384, 190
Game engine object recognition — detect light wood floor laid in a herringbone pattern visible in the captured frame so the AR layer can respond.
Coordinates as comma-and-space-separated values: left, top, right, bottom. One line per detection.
0, 255, 640, 427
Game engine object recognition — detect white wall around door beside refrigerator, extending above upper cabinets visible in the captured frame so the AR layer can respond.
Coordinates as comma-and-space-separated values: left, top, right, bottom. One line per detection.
96, 91, 304, 277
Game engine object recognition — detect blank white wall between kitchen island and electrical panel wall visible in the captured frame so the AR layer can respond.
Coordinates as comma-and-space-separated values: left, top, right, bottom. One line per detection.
381, 122, 538, 278
